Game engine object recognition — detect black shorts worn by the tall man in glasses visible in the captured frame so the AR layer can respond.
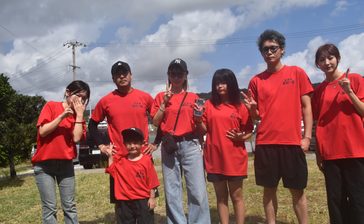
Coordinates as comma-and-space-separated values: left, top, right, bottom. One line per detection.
254, 145, 308, 190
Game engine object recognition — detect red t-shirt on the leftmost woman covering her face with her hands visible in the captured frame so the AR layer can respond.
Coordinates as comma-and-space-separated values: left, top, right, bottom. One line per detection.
32, 101, 86, 164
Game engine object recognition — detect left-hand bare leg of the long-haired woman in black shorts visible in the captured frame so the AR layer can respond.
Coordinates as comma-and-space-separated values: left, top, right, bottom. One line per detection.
213, 181, 229, 224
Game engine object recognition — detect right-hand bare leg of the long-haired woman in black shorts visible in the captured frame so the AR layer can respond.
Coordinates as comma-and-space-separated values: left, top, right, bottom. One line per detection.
228, 180, 245, 224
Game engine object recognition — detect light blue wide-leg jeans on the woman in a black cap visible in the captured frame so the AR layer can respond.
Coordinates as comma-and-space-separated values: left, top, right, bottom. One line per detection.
161, 139, 211, 224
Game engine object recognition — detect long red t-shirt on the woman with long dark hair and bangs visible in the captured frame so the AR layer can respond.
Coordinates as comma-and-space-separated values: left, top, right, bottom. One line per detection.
203, 100, 253, 176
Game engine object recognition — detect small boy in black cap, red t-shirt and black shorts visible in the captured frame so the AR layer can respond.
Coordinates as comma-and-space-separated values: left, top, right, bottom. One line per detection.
106, 128, 159, 224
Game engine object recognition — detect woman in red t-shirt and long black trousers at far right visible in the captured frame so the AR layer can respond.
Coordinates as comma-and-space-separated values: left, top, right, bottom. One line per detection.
312, 44, 364, 223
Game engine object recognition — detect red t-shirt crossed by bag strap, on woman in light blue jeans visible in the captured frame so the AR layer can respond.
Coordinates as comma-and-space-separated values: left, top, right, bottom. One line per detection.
151, 92, 199, 136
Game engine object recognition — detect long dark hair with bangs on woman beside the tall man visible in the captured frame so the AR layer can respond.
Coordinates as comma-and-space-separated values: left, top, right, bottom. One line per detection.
210, 68, 241, 106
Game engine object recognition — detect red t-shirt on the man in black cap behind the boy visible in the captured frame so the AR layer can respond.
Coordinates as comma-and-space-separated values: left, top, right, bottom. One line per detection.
91, 89, 153, 156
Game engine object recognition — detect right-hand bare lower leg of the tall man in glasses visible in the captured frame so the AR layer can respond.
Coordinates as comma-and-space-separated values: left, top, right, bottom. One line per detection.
289, 189, 308, 224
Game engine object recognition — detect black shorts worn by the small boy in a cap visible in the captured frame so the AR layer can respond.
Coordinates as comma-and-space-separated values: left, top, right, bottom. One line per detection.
116, 198, 154, 224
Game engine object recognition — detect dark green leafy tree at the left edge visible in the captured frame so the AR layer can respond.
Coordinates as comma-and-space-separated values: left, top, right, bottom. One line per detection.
0, 74, 45, 177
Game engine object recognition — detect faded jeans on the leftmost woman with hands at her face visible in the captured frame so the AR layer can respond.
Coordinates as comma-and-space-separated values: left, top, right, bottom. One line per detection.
34, 160, 78, 224
